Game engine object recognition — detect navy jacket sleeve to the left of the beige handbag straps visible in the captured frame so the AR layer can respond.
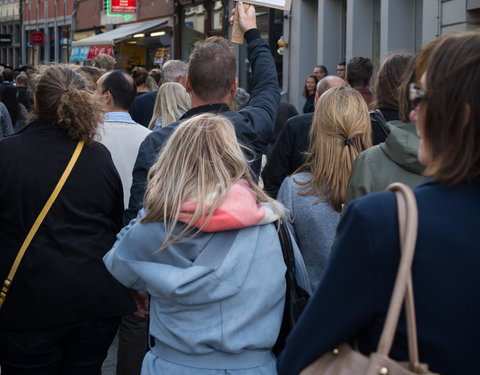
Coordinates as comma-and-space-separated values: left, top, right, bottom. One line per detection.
277, 202, 375, 375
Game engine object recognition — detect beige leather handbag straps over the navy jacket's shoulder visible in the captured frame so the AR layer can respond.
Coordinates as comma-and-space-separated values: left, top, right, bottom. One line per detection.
377, 183, 420, 370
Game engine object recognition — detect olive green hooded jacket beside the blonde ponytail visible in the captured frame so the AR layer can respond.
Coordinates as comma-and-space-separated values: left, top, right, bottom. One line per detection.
346, 121, 425, 203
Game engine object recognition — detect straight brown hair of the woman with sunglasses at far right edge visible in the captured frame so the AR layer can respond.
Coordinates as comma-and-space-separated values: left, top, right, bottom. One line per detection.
417, 32, 480, 185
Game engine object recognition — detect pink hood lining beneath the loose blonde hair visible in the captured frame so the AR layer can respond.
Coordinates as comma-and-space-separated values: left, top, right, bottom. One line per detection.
179, 180, 265, 232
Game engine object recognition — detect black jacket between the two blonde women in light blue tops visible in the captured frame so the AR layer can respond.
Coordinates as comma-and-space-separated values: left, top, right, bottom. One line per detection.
262, 112, 313, 198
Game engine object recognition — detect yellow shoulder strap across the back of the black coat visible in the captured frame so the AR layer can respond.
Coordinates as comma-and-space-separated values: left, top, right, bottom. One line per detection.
0, 141, 84, 309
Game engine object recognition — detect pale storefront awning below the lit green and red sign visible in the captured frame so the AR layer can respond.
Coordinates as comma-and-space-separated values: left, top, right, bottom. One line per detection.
72, 18, 168, 47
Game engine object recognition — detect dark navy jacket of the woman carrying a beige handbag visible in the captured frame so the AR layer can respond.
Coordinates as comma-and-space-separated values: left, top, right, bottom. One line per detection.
277, 181, 480, 375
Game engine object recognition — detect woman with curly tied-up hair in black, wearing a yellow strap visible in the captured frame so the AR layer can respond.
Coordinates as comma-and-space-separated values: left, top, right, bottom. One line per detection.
0, 65, 135, 375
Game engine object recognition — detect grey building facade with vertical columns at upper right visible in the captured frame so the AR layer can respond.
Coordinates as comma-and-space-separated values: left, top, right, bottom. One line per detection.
283, 0, 480, 109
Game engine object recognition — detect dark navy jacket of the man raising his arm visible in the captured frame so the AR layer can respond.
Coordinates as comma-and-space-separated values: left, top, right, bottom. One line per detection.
123, 29, 280, 225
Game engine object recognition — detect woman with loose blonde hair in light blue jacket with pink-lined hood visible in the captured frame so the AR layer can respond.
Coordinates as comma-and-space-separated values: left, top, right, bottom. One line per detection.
104, 114, 309, 375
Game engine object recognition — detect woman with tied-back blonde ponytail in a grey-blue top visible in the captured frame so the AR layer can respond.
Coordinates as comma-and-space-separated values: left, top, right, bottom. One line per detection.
277, 87, 372, 289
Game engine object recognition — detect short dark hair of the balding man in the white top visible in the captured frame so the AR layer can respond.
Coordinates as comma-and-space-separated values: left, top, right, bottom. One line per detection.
103, 70, 137, 110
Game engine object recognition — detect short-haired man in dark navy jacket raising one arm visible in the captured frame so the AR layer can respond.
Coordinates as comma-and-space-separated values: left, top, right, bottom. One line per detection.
124, 2, 280, 224
